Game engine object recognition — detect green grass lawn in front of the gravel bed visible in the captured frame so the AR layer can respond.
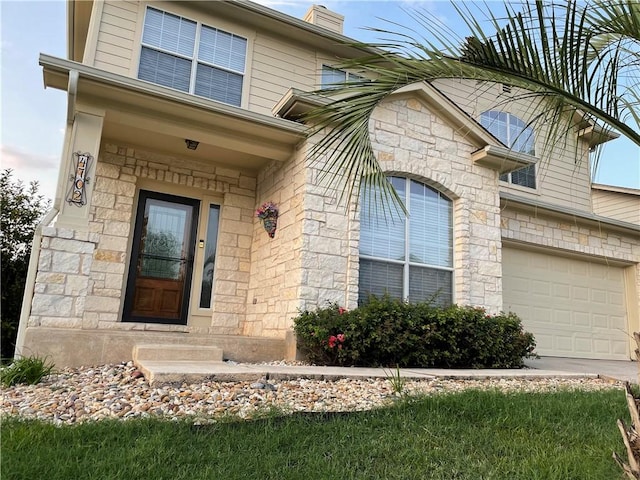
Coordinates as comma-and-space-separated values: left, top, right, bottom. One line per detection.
0, 390, 628, 480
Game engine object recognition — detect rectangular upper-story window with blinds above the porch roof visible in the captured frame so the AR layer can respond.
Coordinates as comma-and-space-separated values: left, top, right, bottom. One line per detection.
138, 7, 247, 106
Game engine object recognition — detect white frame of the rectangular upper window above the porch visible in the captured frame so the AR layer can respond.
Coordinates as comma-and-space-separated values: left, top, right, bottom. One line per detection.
137, 5, 249, 106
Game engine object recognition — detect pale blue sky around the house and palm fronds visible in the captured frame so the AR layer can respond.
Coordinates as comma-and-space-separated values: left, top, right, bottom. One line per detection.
0, 0, 640, 198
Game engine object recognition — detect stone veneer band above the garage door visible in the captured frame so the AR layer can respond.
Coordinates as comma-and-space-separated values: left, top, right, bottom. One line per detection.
501, 208, 640, 320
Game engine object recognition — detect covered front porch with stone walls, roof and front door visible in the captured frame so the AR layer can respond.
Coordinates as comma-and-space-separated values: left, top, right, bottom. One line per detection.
17, 57, 316, 366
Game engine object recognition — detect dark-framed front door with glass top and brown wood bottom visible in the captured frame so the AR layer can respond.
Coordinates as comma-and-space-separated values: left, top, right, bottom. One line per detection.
123, 190, 200, 325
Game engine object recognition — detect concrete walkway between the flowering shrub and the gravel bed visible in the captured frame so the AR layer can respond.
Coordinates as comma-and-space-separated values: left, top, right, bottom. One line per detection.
136, 357, 638, 384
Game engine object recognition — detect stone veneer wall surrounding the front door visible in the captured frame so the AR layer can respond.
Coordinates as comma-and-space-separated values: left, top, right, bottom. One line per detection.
27, 144, 256, 336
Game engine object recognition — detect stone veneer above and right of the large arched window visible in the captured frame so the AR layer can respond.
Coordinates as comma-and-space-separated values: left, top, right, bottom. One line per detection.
370, 98, 502, 313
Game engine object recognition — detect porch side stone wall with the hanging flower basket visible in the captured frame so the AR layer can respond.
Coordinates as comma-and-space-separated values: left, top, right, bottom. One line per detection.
242, 146, 305, 338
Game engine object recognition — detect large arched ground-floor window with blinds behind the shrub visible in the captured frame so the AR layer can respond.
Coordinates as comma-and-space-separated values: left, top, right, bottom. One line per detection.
359, 177, 453, 305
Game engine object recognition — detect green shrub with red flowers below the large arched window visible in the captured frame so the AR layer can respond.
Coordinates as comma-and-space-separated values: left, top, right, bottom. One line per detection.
294, 296, 535, 368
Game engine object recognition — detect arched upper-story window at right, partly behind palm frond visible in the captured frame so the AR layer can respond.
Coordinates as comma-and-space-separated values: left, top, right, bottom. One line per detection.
480, 110, 536, 188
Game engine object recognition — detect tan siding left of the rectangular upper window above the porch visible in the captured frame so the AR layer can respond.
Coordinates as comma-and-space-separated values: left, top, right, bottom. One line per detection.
94, 1, 138, 75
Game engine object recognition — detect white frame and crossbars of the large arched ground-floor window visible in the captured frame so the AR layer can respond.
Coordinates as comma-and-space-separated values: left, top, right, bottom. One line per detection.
358, 175, 455, 304
